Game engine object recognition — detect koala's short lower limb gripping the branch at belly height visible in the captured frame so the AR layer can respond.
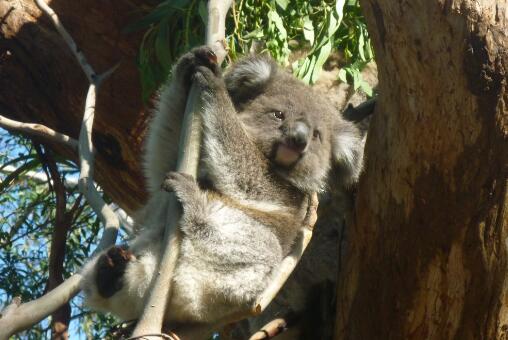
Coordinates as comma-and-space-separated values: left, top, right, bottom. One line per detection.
162, 172, 207, 237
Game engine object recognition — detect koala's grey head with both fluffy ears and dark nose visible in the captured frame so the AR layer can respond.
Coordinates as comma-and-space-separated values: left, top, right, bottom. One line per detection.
225, 56, 363, 192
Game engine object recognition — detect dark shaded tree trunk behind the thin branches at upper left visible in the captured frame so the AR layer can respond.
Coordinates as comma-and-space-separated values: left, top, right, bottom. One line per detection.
0, 0, 149, 212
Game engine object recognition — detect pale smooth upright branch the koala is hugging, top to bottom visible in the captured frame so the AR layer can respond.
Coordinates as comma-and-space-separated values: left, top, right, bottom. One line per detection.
132, 0, 232, 339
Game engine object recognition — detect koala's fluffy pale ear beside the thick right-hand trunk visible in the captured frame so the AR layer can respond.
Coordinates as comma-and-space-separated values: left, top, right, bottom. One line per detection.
332, 120, 366, 187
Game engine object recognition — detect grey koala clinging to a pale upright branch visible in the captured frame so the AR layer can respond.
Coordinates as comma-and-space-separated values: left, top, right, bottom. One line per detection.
82, 47, 363, 334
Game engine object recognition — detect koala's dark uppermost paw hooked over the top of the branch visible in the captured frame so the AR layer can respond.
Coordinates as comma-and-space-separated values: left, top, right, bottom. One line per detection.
174, 46, 220, 85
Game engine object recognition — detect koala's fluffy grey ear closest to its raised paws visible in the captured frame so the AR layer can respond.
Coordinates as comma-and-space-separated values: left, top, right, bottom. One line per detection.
224, 55, 277, 105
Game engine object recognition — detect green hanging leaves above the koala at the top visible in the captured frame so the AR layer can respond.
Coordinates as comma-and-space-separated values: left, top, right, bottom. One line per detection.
127, 0, 373, 101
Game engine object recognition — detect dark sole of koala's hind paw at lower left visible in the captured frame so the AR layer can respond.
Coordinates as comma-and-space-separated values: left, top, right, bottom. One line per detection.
95, 246, 134, 298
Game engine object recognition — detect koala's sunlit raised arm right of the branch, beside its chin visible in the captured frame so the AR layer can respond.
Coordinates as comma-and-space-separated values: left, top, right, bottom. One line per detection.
194, 58, 271, 199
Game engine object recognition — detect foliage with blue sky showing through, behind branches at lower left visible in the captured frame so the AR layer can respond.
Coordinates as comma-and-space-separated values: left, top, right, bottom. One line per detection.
0, 130, 118, 339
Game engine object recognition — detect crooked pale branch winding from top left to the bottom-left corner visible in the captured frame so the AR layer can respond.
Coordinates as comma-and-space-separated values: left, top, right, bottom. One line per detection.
0, 0, 119, 339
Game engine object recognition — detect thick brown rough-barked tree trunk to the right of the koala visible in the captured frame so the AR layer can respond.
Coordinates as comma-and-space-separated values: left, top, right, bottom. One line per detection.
335, 0, 508, 339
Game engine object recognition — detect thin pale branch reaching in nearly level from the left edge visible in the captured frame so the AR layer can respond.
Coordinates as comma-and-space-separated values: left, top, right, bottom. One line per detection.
0, 115, 78, 150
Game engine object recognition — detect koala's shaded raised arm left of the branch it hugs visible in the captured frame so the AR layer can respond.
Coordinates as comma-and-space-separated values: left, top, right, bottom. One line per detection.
145, 48, 218, 193
